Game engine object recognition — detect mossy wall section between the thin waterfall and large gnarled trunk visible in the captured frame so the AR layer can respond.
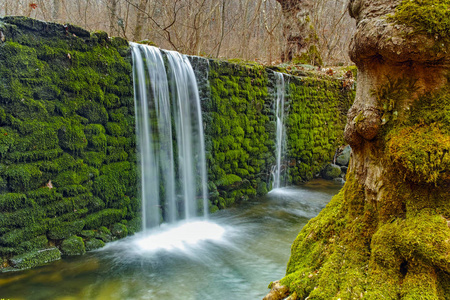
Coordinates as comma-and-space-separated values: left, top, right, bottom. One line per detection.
285, 77, 354, 184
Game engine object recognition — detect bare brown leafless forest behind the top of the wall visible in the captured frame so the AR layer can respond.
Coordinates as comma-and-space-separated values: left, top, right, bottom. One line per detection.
0, 0, 355, 66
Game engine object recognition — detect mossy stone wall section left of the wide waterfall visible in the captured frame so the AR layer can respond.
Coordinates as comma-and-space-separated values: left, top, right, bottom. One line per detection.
0, 17, 139, 268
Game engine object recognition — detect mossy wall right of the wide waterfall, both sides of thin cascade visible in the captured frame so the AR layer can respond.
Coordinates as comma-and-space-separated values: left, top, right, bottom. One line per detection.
199, 60, 354, 211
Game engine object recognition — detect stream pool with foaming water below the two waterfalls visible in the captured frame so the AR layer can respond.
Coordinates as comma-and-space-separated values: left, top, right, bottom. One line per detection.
0, 180, 342, 300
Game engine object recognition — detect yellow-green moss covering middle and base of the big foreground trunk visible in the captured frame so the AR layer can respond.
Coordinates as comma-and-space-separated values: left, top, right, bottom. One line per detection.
282, 68, 450, 299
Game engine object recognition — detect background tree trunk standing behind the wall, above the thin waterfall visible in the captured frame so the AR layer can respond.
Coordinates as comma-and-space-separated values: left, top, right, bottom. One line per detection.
277, 0, 314, 62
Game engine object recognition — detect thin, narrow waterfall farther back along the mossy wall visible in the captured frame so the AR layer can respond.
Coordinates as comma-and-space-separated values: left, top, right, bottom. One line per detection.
272, 72, 286, 189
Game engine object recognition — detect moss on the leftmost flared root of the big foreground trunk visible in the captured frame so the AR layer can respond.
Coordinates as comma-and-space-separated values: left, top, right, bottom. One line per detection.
282, 174, 376, 299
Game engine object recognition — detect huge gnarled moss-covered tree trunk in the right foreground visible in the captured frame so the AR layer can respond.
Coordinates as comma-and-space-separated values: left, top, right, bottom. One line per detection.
273, 0, 450, 299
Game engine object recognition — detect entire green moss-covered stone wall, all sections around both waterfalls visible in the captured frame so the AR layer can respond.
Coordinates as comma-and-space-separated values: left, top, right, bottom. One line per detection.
0, 17, 353, 270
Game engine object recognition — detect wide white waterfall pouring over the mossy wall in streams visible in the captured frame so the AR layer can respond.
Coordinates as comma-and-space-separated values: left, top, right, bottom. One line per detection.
130, 43, 209, 230
